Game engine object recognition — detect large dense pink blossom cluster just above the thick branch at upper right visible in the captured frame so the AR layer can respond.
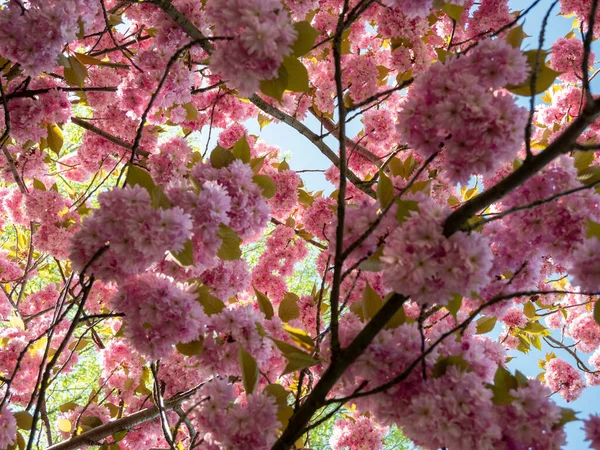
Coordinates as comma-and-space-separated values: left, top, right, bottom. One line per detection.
398, 40, 528, 183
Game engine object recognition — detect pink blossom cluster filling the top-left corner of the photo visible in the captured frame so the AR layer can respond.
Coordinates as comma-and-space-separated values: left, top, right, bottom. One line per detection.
0, 0, 104, 76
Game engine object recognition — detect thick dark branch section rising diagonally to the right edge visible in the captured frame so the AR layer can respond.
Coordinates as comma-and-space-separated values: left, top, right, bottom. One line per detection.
444, 102, 600, 236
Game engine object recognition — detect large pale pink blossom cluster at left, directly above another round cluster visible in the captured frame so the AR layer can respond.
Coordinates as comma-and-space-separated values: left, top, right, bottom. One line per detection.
70, 185, 192, 281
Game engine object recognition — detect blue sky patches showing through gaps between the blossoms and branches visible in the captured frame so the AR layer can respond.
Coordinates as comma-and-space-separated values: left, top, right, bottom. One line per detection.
238, 0, 600, 450
